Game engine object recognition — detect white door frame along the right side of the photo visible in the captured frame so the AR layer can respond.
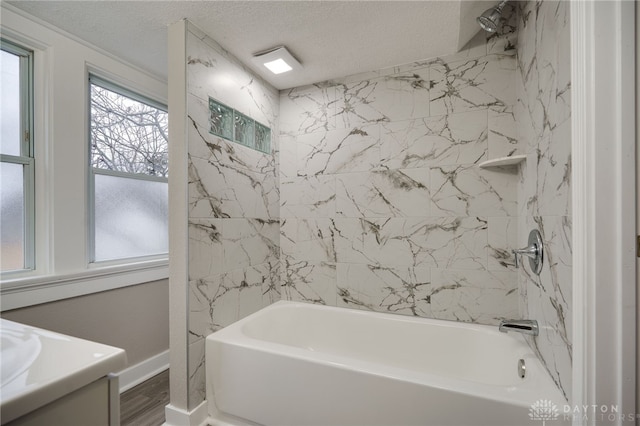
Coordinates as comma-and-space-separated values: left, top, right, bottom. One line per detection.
570, 0, 637, 424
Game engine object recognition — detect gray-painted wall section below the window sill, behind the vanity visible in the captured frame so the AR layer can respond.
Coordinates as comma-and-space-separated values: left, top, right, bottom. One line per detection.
2, 280, 169, 366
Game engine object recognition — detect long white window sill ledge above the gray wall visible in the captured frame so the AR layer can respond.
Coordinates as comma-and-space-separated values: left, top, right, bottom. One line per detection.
0, 259, 169, 312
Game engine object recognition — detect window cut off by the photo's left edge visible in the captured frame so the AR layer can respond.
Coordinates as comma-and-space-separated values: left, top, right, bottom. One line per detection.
0, 40, 35, 273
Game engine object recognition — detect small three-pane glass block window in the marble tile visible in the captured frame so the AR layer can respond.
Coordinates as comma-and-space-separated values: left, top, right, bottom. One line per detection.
209, 97, 271, 154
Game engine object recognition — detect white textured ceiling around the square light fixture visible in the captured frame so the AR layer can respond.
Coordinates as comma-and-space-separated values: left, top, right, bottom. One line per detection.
7, 1, 486, 89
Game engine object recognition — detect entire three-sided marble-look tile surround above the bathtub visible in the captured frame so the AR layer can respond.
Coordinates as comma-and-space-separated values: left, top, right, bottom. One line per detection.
182, 2, 571, 409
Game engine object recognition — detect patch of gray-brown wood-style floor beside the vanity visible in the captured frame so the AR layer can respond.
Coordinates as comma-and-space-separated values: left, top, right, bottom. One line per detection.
120, 370, 169, 426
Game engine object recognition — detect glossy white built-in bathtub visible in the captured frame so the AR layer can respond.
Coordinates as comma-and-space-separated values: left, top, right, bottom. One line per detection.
206, 301, 566, 426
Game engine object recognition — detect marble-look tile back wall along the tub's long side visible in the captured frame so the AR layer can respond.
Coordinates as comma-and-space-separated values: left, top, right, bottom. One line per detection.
280, 5, 521, 324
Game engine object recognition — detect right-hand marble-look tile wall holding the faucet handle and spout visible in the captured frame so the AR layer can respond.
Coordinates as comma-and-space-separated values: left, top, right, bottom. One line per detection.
514, 1, 572, 399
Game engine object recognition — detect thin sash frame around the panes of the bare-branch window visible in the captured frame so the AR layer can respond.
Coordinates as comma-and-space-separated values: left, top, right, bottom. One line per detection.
87, 73, 169, 266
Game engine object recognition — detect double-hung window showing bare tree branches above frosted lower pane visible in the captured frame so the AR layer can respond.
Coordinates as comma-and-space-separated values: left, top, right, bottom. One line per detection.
89, 76, 169, 262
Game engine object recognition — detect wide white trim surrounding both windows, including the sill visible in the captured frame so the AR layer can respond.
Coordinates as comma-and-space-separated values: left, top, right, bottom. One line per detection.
0, 2, 169, 312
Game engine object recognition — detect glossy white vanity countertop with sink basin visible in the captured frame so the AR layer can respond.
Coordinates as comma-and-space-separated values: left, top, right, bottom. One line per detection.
0, 319, 126, 423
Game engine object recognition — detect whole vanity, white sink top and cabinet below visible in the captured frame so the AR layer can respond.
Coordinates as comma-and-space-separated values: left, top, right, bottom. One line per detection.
0, 320, 126, 426
